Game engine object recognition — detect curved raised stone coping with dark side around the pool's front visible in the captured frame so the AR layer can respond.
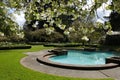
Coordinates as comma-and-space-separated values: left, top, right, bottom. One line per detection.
36, 52, 119, 70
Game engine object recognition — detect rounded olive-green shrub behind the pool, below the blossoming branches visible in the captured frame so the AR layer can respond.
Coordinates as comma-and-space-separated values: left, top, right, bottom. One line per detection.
68, 20, 95, 42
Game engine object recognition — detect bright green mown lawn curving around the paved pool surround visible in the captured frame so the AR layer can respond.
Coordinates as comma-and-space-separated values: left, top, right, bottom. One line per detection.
0, 46, 113, 80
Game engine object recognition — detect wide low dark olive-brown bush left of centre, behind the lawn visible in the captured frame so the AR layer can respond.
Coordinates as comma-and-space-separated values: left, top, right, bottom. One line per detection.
25, 29, 64, 42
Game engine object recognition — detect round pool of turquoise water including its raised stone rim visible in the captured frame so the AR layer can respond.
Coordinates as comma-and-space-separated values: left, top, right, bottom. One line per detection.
37, 50, 119, 70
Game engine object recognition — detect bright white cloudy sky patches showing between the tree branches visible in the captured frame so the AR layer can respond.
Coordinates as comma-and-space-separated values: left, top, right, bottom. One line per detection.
9, 0, 112, 27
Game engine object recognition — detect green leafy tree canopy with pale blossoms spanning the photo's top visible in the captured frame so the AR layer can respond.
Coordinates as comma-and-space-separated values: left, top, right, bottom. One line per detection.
0, 0, 119, 42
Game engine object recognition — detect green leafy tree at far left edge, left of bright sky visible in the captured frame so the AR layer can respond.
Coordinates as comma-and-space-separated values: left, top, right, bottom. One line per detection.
0, 3, 17, 36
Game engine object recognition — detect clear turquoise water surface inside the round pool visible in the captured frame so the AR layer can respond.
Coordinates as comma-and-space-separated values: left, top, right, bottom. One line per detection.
49, 50, 118, 65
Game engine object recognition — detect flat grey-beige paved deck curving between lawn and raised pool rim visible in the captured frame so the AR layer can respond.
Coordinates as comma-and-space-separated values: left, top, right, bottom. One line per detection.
20, 50, 120, 80
